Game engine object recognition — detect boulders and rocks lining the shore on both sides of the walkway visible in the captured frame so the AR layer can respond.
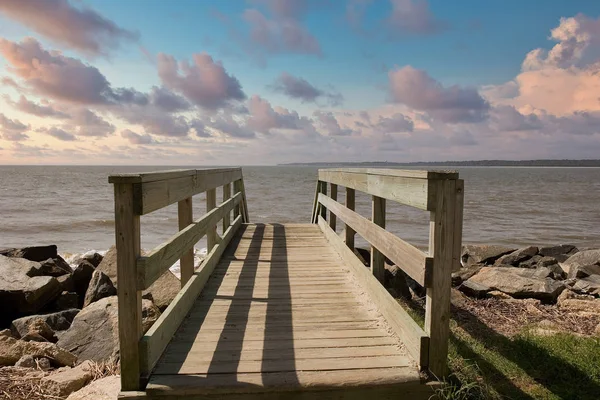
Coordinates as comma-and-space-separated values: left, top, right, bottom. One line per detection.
0, 241, 600, 399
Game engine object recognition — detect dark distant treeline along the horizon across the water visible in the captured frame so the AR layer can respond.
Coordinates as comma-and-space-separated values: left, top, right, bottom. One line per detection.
278, 160, 600, 167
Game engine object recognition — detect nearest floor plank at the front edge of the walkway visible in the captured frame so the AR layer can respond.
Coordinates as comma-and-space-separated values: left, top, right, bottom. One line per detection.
147, 367, 422, 400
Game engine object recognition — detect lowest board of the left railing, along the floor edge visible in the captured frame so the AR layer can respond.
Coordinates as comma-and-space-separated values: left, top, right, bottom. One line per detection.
136, 217, 242, 374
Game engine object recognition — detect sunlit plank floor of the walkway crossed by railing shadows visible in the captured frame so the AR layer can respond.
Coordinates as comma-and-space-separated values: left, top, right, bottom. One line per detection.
146, 224, 432, 399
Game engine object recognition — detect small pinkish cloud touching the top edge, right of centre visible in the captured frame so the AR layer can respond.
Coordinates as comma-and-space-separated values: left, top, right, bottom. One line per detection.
387, 0, 447, 35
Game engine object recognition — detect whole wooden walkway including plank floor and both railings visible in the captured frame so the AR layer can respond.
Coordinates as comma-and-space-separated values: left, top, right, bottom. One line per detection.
110, 169, 462, 399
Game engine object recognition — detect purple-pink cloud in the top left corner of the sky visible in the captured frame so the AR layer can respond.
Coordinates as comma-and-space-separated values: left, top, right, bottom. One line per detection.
0, 0, 138, 55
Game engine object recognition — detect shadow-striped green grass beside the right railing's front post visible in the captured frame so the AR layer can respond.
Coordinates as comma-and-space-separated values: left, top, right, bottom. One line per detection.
403, 292, 600, 400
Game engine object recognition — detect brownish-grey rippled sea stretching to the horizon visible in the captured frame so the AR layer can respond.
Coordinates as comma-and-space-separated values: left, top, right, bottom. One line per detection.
0, 166, 600, 272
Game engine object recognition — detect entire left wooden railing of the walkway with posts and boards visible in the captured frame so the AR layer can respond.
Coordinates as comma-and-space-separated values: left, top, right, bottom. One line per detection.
108, 168, 248, 391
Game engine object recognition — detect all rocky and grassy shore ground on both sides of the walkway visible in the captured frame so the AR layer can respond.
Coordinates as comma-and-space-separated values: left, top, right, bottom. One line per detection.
0, 239, 600, 400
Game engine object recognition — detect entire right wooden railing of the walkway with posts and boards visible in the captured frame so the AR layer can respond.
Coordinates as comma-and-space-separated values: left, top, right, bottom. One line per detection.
312, 168, 463, 377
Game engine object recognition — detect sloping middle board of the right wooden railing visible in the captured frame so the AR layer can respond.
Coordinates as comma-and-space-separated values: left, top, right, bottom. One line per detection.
319, 195, 433, 286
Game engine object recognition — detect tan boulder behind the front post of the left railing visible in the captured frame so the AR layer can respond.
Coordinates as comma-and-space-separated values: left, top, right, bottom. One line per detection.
98, 246, 181, 311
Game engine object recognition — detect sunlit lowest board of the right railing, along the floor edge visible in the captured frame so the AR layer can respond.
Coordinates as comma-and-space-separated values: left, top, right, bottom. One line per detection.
319, 219, 429, 366
